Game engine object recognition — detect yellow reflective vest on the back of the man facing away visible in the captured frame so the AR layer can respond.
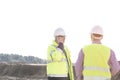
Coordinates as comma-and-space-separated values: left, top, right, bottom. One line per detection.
83, 44, 111, 80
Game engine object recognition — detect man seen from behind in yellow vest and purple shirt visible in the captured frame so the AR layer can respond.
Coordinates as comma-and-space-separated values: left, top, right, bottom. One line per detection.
75, 26, 120, 80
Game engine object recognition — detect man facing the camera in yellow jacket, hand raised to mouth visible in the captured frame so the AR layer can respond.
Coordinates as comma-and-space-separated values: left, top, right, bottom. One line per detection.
47, 28, 74, 80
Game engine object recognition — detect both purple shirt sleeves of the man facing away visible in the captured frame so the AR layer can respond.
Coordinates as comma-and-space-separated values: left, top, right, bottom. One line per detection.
75, 49, 120, 80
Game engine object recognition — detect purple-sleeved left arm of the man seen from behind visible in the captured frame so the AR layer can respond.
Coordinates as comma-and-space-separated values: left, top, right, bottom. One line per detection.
75, 50, 84, 80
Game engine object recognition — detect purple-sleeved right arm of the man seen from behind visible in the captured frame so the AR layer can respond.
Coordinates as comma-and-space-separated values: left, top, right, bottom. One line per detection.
108, 50, 120, 76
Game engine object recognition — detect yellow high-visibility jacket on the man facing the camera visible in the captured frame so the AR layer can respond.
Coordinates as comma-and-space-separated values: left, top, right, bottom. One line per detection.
47, 41, 74, 80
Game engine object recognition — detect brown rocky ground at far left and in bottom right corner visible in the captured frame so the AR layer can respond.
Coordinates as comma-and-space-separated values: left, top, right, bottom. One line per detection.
0, 62, 120, 80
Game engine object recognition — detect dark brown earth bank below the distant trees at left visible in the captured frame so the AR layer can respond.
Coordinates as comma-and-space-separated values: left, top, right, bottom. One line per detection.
0, 63, 46, 79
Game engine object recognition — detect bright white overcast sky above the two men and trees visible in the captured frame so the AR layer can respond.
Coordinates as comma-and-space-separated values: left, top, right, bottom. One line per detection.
0, 0, 120, 62
